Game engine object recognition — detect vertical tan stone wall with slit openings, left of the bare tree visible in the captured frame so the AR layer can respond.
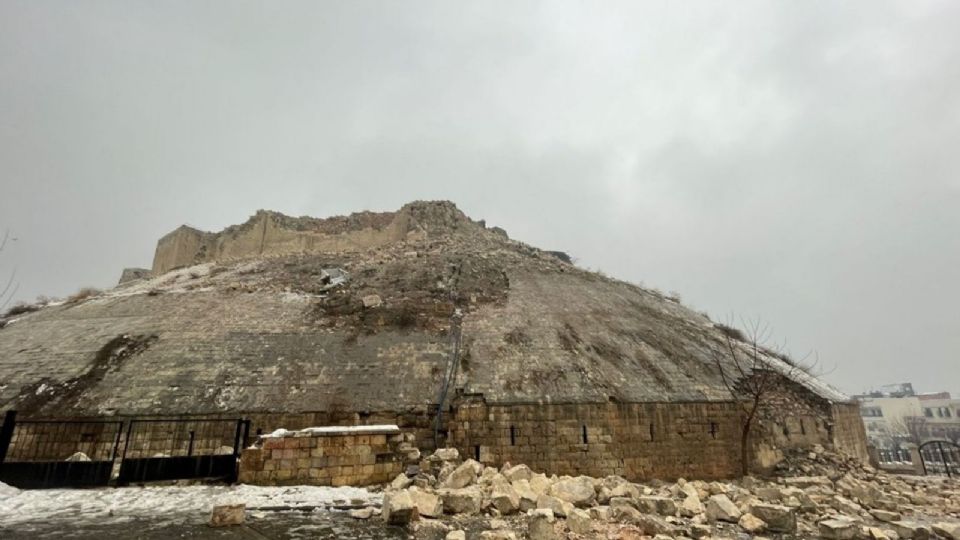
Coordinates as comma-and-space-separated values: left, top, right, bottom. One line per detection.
449, 403, 740, 481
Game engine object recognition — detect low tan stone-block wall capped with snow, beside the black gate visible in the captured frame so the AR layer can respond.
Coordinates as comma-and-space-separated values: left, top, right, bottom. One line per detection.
239, 426, 419, 486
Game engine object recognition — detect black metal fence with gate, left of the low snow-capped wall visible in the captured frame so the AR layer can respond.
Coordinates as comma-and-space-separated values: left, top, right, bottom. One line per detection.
0, 411, 250, 489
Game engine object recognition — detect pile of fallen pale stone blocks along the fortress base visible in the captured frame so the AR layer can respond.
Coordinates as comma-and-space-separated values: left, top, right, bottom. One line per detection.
355, 447, 960, 540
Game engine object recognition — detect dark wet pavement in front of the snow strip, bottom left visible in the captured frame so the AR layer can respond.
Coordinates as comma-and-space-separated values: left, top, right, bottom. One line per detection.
0, 510, 408, 540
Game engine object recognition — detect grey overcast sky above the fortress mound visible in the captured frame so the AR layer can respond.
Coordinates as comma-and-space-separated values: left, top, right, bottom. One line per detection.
0, 0, 960, 393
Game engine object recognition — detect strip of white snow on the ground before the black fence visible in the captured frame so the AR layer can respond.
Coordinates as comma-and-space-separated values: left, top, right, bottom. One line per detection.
0, 484, 381, 525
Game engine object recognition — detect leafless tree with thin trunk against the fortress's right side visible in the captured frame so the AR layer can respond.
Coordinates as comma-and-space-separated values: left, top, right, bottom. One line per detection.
714, 320, 813, 476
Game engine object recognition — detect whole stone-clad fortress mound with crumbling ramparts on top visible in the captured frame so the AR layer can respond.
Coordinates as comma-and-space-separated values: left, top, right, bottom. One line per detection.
0, 203, 866, 479
